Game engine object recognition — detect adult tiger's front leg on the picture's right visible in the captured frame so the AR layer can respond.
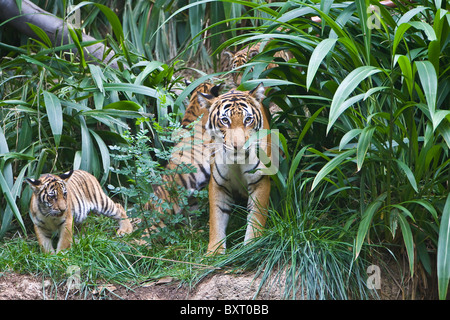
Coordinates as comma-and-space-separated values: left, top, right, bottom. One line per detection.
244, 176, 270, 244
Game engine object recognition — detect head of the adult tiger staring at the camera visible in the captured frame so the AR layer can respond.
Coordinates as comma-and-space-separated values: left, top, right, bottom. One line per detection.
199, 84, 265, 161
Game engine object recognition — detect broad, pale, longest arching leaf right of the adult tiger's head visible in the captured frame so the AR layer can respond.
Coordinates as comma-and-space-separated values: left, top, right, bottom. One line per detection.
327, 66, 381, 134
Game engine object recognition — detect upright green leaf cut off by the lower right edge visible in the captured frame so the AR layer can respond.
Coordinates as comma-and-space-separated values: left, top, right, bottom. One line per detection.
437, 194, 450, 300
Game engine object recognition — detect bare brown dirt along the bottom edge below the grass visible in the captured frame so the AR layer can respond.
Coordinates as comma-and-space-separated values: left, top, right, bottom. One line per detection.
0, 256, 423, 300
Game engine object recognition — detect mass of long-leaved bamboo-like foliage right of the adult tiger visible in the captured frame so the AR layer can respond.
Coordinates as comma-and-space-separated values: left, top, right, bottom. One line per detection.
229, 1, 450, 298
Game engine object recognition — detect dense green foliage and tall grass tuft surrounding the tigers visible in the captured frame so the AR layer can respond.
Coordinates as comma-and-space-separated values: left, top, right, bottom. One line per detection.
0, 0, 450, 299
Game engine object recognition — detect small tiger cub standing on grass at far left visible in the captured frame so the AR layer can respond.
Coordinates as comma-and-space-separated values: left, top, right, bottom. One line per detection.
27, 170, 133, 253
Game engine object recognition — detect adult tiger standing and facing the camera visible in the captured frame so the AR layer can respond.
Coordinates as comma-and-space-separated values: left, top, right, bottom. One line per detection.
198, 84, 271, 253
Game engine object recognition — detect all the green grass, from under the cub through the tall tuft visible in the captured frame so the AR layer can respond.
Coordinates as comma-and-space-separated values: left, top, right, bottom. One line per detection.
0, 192, 374, 299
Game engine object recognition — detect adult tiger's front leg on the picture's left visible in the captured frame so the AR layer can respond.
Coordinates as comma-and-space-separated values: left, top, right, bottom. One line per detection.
207, 180, 231, 254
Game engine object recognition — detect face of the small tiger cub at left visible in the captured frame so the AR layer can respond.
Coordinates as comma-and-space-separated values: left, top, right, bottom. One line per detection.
27, 171, 73, 217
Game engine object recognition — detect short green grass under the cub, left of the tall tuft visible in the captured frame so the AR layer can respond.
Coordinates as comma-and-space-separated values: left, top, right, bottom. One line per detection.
0, 216, 215, 296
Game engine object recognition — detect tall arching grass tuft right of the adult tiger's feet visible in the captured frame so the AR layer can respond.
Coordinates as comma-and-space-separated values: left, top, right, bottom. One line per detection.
197, 181, 377, 300
